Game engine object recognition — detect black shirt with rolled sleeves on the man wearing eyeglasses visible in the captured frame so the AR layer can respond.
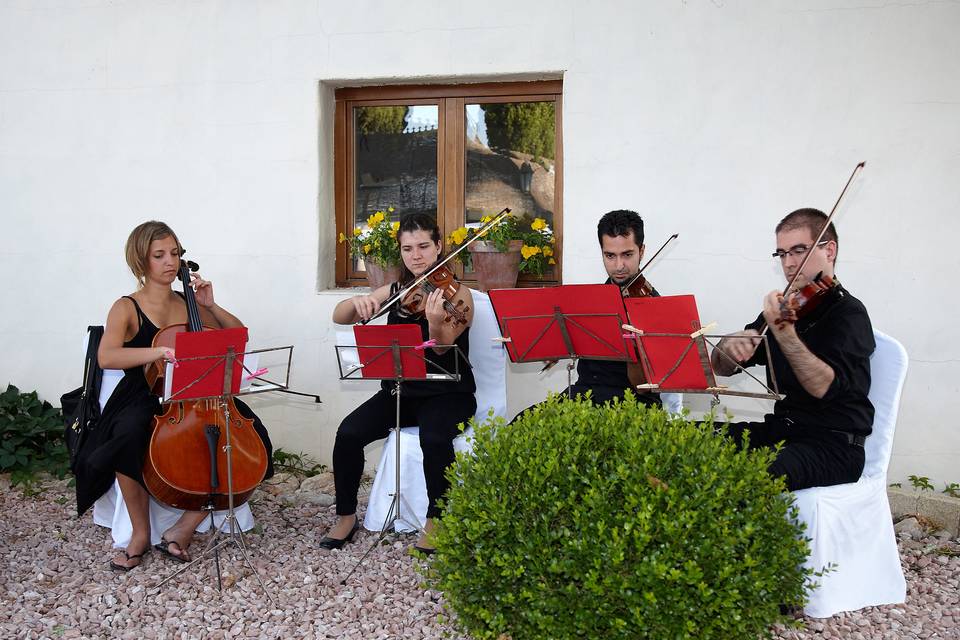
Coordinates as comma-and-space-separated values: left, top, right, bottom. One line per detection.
744, 285, 876, 436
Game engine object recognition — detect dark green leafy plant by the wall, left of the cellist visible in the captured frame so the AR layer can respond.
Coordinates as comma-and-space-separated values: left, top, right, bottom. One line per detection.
0, 384, 70, 485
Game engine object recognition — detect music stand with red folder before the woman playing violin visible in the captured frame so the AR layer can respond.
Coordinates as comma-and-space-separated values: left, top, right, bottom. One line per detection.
335, 324, 462, 585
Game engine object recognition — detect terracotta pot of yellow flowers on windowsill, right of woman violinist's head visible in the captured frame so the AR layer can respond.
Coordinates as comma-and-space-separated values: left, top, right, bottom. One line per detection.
447, 215, 557, 291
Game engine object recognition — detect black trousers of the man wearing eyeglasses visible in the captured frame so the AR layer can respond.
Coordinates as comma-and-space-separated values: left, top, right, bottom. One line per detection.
728, 419, 864, 491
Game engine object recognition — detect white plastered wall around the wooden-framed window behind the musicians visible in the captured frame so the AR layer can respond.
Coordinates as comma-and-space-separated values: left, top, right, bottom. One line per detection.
0, 0, 960, 484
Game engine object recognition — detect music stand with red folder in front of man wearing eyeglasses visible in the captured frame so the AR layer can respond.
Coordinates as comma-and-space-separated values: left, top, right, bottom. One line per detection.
624, 295, 779, 402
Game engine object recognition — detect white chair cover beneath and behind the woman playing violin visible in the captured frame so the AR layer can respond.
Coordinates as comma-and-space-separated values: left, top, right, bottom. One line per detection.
362, 290, 507, 531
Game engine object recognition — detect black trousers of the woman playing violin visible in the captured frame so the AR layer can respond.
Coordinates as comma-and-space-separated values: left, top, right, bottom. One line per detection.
333, 389, 477, 518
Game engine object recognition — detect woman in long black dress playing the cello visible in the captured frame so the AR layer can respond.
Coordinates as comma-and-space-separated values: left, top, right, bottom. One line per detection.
77, 221, 272, 571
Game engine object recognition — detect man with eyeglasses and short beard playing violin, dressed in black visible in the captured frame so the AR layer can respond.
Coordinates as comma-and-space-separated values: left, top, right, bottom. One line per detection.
710, 209, 875, 491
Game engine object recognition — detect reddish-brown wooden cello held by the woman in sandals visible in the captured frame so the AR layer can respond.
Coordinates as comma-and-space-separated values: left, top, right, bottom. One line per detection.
143, 260, 268, 511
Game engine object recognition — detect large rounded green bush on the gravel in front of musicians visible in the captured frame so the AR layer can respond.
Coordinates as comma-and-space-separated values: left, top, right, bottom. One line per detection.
424, 396, 809, 640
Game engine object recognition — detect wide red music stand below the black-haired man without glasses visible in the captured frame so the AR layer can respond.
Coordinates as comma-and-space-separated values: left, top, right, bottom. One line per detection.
490, 284, 637, 392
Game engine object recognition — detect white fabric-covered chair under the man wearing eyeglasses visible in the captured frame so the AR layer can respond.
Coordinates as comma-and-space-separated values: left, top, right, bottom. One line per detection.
794, 331, 908, 618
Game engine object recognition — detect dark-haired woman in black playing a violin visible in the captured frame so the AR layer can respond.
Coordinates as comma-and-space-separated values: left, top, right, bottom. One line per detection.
320, 213, 477, 553
